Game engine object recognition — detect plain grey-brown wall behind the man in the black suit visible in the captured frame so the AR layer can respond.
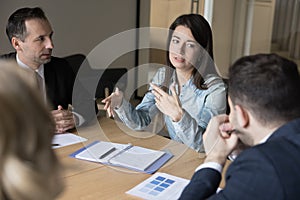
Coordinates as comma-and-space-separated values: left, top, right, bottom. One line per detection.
0, 0, 137, 98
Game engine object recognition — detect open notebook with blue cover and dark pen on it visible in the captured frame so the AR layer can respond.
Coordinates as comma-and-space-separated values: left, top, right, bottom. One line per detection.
70, 141, 173, 174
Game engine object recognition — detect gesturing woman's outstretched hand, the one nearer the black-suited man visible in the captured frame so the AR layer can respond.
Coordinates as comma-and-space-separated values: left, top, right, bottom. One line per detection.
101, 88, 124, 117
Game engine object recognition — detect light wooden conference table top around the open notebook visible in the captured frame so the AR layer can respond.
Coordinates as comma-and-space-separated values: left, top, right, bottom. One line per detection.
55, 117, 230, 200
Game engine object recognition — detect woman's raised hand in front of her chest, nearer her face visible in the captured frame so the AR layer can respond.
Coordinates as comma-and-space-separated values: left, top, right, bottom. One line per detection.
150, 83, 183, 122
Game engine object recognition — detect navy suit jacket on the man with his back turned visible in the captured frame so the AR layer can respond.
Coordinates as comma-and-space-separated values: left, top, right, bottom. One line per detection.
180, 119, 300, 200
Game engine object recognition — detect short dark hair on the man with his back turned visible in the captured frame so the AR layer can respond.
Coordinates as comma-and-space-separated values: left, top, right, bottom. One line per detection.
228, 54, 300, 124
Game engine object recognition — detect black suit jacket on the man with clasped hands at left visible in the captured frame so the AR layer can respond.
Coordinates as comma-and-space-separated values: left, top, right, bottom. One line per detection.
0, 53, 98, 126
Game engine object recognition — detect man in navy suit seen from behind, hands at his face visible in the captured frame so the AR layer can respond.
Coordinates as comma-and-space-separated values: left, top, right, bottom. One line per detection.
180, 54, 300, 200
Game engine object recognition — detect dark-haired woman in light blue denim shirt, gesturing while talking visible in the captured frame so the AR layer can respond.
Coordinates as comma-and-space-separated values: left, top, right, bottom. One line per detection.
103, 14, 226, 151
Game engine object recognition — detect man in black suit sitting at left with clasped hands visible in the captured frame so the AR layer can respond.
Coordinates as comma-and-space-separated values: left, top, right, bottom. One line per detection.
1, 7, 97, 133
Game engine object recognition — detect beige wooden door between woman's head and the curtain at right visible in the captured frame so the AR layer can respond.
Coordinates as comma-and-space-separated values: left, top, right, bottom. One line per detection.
210, 0, 275, 77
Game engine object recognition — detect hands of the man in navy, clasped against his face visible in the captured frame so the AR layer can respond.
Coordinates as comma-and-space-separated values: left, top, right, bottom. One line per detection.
203, 115, 238, 165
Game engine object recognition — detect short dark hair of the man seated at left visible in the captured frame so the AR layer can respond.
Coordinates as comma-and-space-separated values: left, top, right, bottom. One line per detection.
6, 7, 48, 42
